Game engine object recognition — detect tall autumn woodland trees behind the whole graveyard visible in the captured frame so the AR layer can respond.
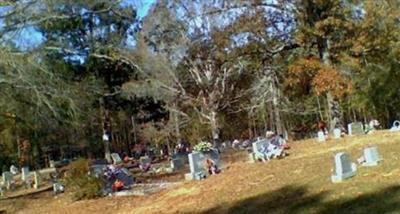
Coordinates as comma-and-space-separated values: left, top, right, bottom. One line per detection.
0, 0, 400, 165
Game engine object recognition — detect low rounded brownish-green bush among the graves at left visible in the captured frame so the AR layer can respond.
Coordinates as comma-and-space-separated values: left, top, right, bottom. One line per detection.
65, 159, 103, 200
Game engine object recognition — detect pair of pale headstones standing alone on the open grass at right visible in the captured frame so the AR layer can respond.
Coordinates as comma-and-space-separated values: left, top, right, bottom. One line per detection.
331, 146, 381, 182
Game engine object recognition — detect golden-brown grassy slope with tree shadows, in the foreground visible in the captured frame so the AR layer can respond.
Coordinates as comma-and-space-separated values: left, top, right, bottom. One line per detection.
0, 131, 400, 214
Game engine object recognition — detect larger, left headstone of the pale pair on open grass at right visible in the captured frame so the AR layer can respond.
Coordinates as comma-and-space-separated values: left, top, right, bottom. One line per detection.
331, 152, 357, 183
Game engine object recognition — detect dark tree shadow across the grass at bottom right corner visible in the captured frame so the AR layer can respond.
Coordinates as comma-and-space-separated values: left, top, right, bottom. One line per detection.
202, 185, 400, 214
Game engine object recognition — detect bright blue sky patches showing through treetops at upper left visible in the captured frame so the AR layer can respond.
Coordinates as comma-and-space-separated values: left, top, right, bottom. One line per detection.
6, 0, 156, 50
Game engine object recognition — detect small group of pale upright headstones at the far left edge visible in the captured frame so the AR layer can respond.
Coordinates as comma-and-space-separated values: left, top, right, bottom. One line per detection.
2, 167, 41, 189
